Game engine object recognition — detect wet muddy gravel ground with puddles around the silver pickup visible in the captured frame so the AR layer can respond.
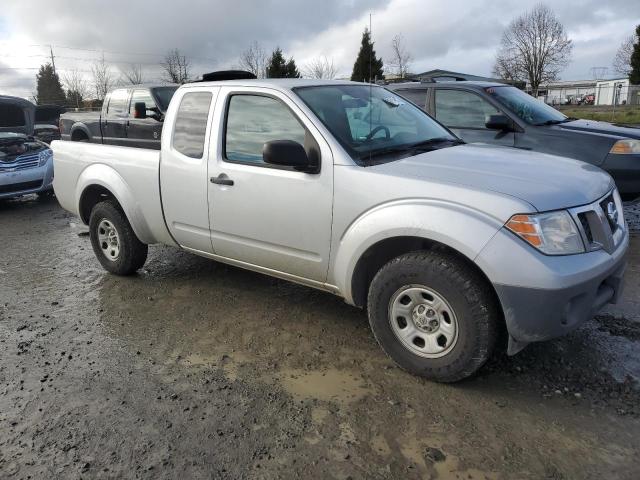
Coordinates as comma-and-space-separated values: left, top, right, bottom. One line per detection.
0, 198, 640, 479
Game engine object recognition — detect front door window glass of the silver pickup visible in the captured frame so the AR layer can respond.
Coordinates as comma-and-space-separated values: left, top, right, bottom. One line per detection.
224, 95, 306, 166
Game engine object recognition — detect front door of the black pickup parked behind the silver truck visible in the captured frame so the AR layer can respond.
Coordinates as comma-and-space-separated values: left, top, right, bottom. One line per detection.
127, 88, 162, 150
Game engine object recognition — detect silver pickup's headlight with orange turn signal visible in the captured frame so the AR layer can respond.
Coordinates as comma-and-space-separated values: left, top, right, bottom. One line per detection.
505, 210, 585, 255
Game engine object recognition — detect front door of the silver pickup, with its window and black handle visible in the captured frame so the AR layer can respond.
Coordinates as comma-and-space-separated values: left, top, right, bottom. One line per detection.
209, 87, 333, 282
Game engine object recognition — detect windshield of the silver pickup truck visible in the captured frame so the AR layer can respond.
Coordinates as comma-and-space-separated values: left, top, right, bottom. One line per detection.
294, 85, 461, 164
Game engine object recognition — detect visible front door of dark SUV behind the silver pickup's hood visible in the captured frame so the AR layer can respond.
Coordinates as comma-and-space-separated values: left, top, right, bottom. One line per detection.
433, 88, 515, 147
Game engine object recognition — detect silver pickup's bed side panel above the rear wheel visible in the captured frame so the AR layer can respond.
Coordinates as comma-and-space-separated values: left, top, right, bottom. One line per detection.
51, 141, 174, 245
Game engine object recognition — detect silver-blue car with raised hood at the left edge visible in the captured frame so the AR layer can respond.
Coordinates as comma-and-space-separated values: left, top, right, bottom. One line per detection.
0, 96, 53, 199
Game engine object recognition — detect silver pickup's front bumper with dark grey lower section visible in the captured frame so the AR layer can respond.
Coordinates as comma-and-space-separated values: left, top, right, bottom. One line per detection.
476, 221, 629, 355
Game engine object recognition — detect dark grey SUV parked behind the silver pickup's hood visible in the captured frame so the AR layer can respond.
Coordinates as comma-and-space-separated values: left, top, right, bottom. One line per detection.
388, 82, 640, 198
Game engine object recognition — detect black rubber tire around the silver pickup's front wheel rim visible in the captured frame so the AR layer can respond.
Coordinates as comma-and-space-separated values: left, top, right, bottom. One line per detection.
367, 250, 501, 382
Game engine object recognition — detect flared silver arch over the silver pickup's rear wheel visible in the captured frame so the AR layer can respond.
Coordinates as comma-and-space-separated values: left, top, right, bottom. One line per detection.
75, 163, 156, 244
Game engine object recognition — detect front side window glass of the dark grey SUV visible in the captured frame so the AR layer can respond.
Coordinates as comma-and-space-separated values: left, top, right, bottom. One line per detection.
436, 89, 500, 129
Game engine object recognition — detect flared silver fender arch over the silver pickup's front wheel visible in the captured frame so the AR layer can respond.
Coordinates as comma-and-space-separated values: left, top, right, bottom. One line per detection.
329, 199, 504, 304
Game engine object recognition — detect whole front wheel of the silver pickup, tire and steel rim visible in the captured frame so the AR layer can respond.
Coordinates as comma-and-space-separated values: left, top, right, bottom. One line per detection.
367, 251, 499, 382
